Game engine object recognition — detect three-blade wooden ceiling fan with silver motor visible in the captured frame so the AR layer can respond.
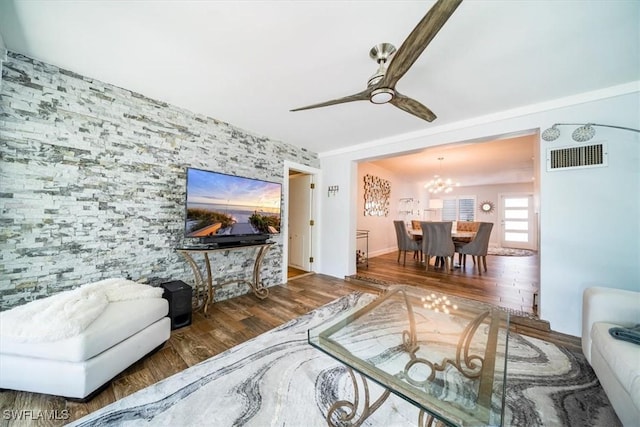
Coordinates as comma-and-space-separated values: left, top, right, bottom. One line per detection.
291, 0, 462, 122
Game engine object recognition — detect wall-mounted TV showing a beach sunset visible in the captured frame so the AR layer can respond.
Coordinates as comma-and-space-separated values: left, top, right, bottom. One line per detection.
185, 168, 282, 242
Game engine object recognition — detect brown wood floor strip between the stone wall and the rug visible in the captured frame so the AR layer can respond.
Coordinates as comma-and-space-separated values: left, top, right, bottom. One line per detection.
0, 275, 376, 426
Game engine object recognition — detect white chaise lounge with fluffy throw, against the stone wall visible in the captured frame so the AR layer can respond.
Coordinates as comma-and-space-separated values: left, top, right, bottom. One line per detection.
0, 279, 171, 400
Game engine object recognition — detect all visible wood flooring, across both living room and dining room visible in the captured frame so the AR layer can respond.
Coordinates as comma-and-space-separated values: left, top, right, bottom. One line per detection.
0, 266, 580, 426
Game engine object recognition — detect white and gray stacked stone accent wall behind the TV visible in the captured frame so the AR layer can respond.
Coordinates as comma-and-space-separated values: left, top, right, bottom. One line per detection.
0, 52, 319, 310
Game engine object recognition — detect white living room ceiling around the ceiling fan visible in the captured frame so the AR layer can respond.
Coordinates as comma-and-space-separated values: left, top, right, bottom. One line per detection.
0, 0, 640, 185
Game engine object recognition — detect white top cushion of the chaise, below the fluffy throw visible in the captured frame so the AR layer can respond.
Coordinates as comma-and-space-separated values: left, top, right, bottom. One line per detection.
0, 298, 169, 362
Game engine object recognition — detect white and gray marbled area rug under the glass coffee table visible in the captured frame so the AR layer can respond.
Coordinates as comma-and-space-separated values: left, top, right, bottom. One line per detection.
71, 293, 620, 427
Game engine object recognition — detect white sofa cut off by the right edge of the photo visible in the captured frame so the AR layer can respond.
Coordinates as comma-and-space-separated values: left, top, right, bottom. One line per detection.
582, 287, 640, 427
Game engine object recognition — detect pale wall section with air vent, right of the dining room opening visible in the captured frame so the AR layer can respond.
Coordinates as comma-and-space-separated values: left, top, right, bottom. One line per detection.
540, 94, 640, 335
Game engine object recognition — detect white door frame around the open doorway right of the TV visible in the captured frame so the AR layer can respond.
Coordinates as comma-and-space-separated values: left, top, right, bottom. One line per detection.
281, 160, 322, 283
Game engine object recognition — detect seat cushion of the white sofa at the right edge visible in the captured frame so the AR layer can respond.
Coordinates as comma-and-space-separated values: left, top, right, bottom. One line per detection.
591, 322, 640, 408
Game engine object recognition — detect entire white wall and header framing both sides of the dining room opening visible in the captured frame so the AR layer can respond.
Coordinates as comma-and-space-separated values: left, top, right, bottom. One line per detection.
320, 86, 640, 336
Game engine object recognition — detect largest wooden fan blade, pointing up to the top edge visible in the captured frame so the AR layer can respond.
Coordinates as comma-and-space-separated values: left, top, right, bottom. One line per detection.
377, 0, 462, 88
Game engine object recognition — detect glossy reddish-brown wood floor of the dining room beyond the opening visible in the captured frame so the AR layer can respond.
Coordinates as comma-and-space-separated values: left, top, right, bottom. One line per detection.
356, 251, 540, 316
